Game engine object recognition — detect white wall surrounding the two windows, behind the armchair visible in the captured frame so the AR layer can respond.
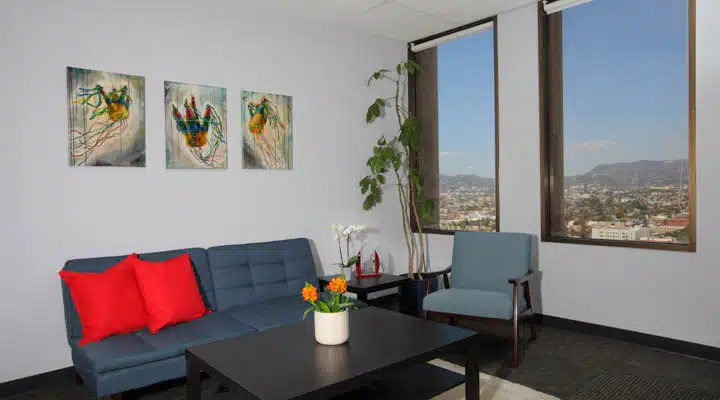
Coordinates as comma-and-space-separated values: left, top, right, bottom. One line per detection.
430, 0, 720, 347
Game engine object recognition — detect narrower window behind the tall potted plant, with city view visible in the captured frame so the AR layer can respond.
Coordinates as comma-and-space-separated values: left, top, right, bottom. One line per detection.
409, 19, 499, 234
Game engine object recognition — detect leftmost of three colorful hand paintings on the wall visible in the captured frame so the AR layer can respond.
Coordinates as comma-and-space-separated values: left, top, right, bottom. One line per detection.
67, 67, 145, 167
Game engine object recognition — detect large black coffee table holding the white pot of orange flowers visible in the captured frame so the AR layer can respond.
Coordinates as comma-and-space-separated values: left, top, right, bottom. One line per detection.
185, 307, 480, 400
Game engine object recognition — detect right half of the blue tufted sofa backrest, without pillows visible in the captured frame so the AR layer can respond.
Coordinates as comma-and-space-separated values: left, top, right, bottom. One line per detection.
202, 239, 317, 310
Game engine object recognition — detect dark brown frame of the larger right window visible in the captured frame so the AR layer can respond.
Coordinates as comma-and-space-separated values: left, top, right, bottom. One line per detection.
538, 0, 697, 252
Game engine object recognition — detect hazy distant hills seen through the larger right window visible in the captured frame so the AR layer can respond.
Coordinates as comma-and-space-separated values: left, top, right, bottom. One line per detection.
565, 160, 688, 187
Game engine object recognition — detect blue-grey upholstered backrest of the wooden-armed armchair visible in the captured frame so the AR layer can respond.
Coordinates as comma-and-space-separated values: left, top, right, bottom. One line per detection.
452, 232, 532, 293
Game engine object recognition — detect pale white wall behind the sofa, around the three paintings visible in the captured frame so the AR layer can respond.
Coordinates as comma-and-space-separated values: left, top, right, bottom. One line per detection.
0, 0, 405, 382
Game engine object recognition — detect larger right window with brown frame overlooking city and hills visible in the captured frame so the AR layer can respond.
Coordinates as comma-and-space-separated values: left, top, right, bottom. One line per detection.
540, 0, 695, 251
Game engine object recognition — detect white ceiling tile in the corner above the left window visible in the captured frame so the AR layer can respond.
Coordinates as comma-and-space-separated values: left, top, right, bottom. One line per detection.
344, 3, 455, 41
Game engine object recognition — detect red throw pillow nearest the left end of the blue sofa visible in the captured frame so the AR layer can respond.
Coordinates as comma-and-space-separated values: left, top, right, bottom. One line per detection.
60, 254, 148, 346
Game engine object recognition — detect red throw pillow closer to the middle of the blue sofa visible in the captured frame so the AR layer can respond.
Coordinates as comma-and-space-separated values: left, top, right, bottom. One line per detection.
135, 254, 208, 333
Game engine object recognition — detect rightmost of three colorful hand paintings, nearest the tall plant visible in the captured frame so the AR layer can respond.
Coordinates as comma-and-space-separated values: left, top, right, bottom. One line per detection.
242, 91, 293, 169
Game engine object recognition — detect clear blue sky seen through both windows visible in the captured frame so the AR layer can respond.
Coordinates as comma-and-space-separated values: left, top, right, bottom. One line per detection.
438, 0, 688, 177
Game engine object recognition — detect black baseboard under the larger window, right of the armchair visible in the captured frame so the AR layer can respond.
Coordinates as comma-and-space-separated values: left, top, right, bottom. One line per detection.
537, 314, 720, 362
